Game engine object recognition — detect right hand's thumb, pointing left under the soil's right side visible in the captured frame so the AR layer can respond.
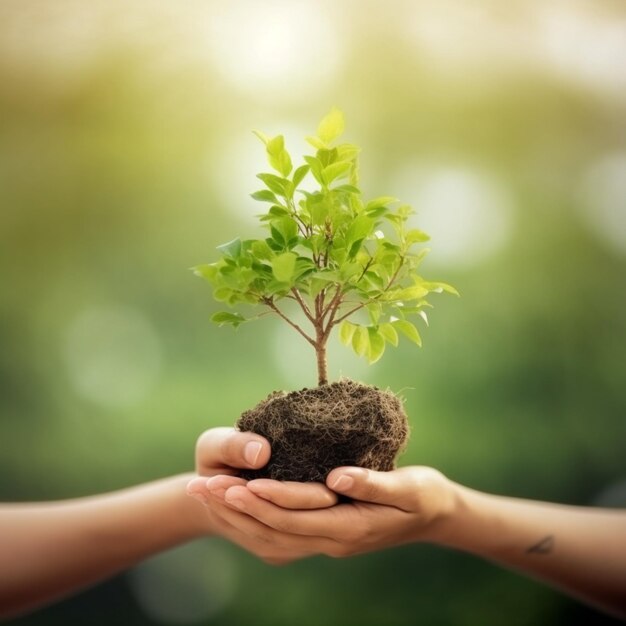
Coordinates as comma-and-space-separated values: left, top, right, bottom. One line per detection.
326, 467, 410, 510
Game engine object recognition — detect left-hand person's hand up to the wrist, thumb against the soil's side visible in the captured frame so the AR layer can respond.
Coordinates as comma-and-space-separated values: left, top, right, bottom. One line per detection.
187, 428, 337, 564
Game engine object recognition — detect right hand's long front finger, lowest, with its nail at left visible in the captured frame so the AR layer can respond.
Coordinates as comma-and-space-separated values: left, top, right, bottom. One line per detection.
224, 486, 360, 539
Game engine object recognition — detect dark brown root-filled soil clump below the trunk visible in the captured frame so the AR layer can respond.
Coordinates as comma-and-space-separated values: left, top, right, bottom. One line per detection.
236, 380, 409, 482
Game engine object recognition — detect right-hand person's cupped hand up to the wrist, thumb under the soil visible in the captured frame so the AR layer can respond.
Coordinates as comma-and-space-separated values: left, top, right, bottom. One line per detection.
207, 467, 457, 557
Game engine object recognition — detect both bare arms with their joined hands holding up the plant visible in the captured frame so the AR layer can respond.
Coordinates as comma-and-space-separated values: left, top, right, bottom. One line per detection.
0, 428, 626, 618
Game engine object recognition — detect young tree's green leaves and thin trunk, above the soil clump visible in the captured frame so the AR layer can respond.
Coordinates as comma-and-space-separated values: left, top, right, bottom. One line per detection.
193, 108, 458, 386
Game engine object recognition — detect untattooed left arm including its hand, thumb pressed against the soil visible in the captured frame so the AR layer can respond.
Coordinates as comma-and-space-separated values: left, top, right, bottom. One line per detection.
0, 428, 336, 617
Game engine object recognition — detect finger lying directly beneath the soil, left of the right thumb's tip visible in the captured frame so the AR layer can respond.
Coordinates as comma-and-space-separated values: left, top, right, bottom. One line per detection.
246, 478, 338, 509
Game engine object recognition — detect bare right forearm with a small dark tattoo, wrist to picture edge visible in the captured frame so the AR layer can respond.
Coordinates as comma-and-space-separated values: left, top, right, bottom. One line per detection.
438, 487, 626, 618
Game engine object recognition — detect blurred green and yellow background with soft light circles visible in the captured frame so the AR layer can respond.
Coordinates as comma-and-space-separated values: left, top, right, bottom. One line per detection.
0, 0, 626, 626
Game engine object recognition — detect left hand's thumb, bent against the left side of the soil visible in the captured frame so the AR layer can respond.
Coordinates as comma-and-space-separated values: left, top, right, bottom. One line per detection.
196, 428, 271, 475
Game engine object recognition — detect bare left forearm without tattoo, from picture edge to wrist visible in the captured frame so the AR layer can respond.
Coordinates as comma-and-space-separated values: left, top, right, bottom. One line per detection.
0, 474, 207, 615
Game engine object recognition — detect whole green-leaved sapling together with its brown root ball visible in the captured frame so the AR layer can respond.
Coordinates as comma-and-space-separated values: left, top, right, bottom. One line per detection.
194, 108, 458, 480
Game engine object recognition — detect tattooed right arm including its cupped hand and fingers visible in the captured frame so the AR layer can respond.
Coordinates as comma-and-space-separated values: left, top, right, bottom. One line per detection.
196, 460, 626, 618
